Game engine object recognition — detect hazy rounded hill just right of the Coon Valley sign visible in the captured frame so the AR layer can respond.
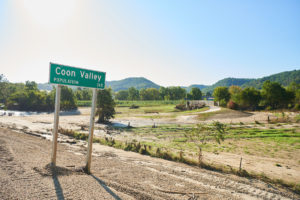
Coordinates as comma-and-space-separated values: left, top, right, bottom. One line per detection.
106, 77, 160, 92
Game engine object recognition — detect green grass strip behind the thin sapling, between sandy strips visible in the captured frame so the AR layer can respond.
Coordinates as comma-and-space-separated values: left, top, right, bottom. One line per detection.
110, 125, 300, 158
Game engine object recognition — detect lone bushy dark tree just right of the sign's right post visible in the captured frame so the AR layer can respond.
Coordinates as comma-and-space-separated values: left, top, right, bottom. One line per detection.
96, 88, 116, 123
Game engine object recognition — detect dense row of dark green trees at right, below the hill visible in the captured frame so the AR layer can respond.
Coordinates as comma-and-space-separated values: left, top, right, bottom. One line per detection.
213, 80, 300, 110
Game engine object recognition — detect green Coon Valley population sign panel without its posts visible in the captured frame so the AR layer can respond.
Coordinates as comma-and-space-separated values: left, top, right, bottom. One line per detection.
49, 63, 106, 89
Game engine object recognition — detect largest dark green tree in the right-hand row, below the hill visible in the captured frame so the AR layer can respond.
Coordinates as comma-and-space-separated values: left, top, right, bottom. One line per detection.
261, 80, 294, 109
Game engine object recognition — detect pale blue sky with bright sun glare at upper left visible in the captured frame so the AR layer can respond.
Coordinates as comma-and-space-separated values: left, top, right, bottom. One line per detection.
0, 0, 300, 86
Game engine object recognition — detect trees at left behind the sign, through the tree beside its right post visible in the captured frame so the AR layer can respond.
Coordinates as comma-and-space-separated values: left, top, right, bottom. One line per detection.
0, 75, 115, 123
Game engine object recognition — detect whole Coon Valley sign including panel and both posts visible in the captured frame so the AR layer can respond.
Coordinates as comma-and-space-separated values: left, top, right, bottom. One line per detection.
49, 63, 106, 173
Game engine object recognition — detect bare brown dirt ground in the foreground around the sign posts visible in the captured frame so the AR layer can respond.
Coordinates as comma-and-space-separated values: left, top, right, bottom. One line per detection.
0, 128, 300, 199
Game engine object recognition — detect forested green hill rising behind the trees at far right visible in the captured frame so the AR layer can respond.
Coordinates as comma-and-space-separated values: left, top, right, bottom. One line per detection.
242, 70, 300, 89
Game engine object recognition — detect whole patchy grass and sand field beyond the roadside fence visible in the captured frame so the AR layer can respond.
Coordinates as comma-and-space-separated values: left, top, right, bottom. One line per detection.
74, 101, 300, 192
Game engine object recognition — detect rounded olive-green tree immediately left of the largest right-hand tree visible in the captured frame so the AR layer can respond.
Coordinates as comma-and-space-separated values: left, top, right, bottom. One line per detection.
239, 87, 261, 110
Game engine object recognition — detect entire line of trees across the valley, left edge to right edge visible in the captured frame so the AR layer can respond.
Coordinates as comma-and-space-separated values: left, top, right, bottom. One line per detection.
0, 72, 300, 115
